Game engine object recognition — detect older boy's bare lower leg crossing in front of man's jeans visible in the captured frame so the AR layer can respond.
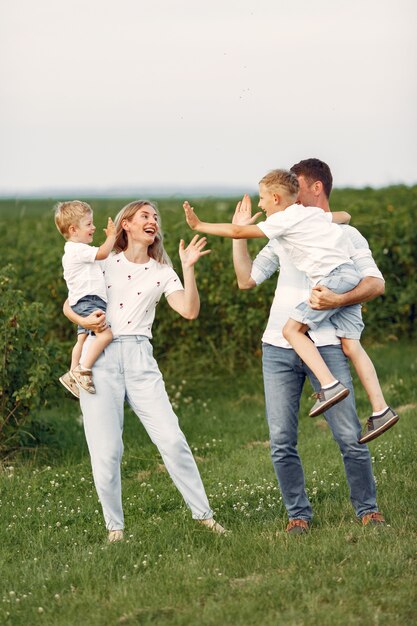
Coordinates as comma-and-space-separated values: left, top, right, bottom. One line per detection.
282, 319, 335, 387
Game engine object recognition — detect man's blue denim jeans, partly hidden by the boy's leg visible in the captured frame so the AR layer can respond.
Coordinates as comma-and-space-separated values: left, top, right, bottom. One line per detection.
263, 344, 378, 521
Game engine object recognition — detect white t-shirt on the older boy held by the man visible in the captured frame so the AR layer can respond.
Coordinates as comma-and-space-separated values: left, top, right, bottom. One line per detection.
257, 204, 355, 285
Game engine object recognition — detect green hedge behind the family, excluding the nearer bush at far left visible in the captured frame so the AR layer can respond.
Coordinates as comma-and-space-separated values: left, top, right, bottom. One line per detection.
0, 186, 417, 394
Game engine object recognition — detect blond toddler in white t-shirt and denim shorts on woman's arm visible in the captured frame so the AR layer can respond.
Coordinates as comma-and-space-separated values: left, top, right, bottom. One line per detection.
55, 200, 116, 397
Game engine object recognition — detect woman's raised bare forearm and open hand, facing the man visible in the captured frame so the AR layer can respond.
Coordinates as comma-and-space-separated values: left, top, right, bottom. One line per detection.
167, 235, 211, 320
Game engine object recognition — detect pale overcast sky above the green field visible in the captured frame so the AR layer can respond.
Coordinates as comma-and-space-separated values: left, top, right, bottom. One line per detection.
0, 0, 417, 196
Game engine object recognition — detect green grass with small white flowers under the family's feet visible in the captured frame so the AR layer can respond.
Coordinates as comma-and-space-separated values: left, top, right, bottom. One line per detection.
0, 343, 417, 626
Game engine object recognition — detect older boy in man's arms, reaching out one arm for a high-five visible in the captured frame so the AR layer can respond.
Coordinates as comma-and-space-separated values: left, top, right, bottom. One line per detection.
183, 170, 399, 443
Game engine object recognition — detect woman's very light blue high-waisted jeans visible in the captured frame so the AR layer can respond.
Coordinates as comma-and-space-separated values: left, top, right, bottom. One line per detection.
80, 335, 213, 530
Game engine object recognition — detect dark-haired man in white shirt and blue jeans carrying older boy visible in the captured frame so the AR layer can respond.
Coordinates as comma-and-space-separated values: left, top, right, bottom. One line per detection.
233, 159, 384, 534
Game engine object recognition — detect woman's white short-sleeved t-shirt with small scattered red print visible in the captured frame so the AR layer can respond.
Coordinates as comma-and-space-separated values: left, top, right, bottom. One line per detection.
100, 252, 184, 338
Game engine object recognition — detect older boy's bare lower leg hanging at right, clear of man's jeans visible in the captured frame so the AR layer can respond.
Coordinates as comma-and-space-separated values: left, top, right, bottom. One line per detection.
341, 337, 388, 413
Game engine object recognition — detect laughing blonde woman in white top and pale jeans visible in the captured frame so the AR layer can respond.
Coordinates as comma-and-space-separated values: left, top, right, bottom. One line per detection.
64, 201, 225, 541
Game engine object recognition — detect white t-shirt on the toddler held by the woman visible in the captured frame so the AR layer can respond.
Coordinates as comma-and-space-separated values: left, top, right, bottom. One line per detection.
62, 241, 107, 306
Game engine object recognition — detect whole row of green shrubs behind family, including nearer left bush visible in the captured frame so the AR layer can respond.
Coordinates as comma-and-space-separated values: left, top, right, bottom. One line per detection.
0, 186, 417, 453
